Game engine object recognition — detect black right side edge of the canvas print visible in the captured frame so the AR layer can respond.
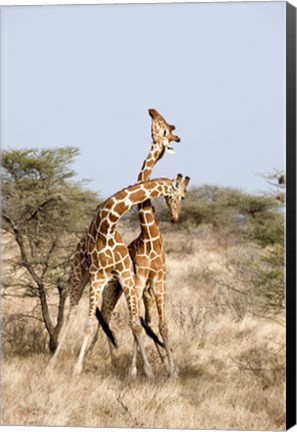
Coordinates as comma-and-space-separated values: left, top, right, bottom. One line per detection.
286, 3, 296, 429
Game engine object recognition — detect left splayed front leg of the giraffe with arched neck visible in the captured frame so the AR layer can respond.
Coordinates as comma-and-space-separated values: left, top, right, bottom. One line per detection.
73, 273, 108, 375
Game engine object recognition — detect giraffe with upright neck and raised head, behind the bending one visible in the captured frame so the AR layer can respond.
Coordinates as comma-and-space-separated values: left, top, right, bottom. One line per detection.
97, 109, 190, 377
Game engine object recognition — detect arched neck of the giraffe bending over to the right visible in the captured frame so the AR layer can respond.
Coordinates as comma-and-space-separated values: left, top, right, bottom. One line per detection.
89, 178, 172, 238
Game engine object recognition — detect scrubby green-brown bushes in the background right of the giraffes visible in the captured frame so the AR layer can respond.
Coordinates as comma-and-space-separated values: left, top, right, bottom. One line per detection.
157, 185, 284, 309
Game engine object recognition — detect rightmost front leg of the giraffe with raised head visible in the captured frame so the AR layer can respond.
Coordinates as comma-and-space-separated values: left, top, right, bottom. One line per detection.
153, 276, 178, 378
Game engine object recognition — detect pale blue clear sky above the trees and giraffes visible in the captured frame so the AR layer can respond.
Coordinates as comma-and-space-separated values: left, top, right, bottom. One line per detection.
1, 2, 285, 196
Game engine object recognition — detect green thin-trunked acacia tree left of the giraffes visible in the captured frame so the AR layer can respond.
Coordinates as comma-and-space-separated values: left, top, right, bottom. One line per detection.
1, 147, 98, 352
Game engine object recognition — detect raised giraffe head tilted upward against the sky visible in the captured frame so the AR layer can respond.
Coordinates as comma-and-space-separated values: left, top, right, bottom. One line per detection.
148, 108, 180, 157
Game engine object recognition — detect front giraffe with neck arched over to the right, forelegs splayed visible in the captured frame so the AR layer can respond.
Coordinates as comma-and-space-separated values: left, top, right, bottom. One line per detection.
53, 174, 186, 378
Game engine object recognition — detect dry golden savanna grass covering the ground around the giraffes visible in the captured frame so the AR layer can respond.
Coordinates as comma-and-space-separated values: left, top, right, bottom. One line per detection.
1, 226, 285, 430
